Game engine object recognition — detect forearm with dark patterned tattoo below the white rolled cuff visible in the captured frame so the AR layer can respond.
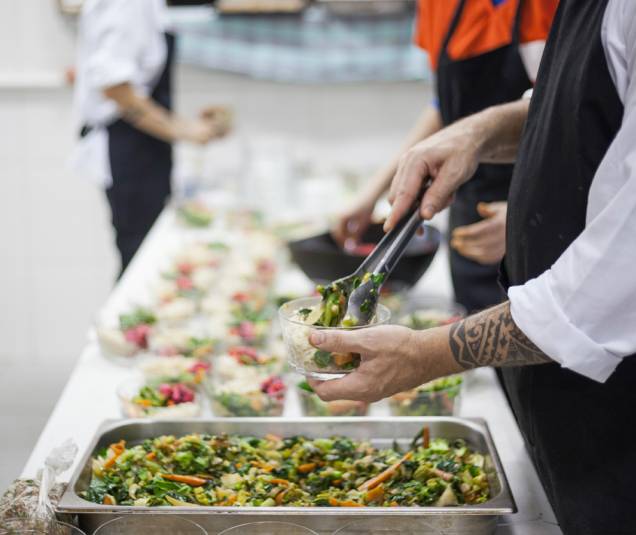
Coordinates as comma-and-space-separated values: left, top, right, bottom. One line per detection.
449, 302, 551, 369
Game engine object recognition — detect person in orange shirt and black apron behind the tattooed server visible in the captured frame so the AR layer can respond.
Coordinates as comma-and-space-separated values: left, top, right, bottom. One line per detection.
334, 0, 558, 311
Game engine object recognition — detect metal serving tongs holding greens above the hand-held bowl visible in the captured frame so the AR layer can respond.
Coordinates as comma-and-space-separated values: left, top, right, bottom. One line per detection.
332, 192, 424, 326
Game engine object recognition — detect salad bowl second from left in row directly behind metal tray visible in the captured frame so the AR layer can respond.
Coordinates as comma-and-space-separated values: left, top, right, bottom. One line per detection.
209, 375, 287, 417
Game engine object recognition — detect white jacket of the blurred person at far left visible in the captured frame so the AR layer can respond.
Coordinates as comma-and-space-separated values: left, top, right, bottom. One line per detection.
71, 0, 167, 187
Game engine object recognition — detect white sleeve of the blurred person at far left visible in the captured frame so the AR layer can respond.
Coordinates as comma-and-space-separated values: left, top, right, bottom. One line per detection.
83, 0, 147, 89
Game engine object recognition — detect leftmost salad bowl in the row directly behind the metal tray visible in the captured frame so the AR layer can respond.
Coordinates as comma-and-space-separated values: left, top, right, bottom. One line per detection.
117, 378, 202, 419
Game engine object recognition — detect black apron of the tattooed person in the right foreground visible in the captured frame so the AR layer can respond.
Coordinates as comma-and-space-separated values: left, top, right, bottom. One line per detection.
504, 0, 636, 535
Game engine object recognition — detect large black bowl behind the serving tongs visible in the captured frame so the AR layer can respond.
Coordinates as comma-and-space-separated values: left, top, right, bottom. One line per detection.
287, 223, 441, 290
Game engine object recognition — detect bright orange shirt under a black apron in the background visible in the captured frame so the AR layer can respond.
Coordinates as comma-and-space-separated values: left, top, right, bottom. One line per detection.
415, 0, 559, 70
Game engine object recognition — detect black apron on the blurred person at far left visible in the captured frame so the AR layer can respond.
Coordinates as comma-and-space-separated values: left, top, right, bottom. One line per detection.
106, 35, 174, 272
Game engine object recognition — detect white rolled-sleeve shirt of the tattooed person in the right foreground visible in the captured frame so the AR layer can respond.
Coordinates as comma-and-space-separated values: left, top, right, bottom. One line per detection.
508, 0, 636, 382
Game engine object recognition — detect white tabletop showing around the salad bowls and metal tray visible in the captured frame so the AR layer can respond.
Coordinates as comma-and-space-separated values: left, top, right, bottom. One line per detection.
22, 203, 561, 535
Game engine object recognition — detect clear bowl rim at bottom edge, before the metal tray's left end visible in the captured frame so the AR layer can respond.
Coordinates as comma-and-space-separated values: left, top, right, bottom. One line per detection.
93, 515, 207, 535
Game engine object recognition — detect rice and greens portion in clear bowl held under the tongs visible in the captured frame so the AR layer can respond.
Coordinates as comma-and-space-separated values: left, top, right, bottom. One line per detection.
279, 293, 391, 379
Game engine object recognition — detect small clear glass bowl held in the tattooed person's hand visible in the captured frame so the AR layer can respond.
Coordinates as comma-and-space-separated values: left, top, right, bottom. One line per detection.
278, 297, 391, 380
